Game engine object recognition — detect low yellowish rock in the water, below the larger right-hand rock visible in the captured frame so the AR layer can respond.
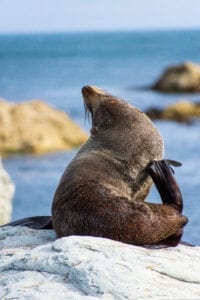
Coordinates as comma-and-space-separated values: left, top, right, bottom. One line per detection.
146, 101, 200, 123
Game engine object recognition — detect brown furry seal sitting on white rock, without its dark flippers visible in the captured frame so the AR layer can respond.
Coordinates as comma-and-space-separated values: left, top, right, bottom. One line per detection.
52, 86, 187, 245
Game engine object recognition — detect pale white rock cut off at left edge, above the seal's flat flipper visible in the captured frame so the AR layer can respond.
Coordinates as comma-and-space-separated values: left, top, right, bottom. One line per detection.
0, 158, 15, 225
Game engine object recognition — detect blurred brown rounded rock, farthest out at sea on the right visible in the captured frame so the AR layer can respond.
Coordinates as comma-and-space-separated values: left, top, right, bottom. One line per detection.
152, 62, 200, 93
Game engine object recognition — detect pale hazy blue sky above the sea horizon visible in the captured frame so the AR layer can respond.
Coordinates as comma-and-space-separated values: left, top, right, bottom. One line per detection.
0, 0, 200, 32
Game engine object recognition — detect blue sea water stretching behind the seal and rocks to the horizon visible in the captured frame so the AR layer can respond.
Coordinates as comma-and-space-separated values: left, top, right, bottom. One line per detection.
0, 30, 200, 244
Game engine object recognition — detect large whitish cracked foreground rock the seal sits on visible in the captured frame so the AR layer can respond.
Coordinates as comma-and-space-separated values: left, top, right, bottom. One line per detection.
0, 227, 200, 300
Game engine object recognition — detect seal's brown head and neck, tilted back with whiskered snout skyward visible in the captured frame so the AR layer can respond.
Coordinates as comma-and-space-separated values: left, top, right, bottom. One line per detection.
82, 86, 163, 159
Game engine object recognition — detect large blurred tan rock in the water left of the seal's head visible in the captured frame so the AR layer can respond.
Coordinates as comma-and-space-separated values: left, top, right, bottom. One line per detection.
0, 100, 87, 154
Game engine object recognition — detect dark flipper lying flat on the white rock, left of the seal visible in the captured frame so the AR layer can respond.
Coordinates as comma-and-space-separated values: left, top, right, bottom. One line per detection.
0, 216, 53, 229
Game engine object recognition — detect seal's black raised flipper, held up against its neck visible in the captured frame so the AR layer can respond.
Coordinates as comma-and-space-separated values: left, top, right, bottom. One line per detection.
146, 160, 183, 213
